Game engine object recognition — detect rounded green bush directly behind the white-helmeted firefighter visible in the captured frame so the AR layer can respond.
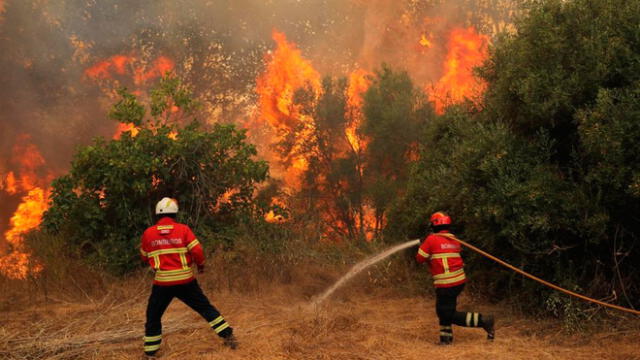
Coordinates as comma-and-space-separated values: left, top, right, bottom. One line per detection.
43, 78, 268, 272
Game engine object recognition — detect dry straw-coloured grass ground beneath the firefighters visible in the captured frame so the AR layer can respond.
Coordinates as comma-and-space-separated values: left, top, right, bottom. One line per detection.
0, 272, 640, 360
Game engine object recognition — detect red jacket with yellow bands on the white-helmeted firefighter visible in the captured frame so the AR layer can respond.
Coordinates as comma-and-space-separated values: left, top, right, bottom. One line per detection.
140, 217, 204, 286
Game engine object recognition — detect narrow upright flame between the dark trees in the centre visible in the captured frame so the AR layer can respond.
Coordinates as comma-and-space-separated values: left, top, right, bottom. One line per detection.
345, 69, 372, 153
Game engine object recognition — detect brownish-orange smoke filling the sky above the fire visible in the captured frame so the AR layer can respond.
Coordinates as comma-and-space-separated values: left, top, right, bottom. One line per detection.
0, 0, 516, 248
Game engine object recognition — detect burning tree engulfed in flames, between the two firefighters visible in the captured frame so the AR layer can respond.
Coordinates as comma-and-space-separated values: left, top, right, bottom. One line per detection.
257, 31, 429, 240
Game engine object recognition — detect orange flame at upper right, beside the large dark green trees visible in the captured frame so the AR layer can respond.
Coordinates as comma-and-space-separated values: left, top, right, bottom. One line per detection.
427, 27, 489, 114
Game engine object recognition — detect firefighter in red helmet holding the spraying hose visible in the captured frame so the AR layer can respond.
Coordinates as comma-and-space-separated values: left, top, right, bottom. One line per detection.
416, 212, 495, 345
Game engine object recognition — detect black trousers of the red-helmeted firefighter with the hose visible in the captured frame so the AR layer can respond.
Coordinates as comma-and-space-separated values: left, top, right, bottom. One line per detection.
436, 284, 483, 343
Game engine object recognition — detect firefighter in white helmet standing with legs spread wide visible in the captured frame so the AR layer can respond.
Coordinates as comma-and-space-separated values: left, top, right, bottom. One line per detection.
140, 198, 237, 356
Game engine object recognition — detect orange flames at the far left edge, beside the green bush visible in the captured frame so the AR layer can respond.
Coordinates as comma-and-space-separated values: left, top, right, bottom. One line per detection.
0, 135, 51, 279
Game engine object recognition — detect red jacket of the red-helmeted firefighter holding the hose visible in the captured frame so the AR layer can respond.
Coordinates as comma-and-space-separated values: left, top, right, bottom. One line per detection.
416, 230, 467, 287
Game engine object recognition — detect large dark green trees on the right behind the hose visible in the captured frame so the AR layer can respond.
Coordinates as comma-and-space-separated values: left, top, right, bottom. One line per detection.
387, 0, 640, 312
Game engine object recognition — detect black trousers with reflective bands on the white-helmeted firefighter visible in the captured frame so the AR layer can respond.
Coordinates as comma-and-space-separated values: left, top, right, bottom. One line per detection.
144, 280, 233, 355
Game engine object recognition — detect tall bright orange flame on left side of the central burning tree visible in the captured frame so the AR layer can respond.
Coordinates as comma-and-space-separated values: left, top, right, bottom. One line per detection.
256, 30, 322, 187
